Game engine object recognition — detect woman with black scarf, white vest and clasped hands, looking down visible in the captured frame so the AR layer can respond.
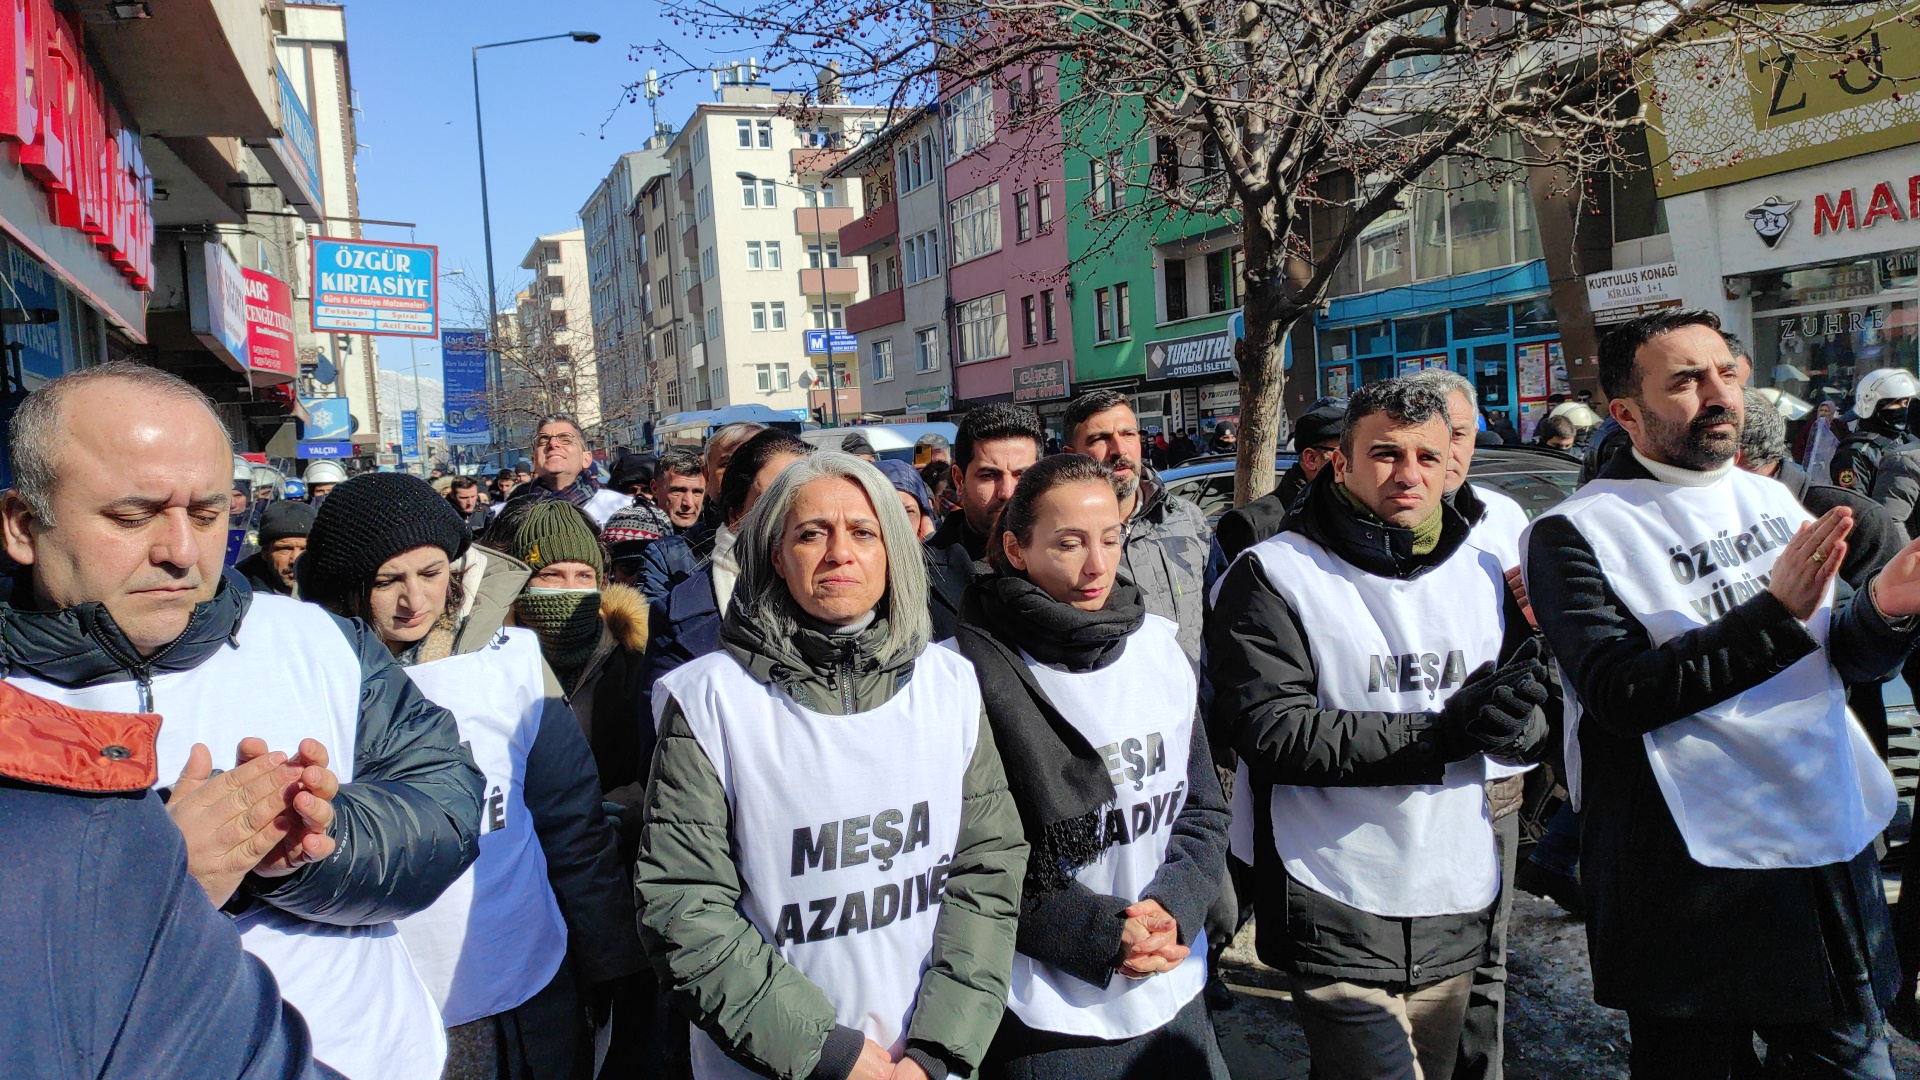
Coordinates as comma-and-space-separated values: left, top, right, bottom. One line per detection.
958, 455, 1227, 1080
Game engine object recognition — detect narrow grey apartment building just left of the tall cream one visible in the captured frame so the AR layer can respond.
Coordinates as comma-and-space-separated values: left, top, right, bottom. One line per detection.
580, 146, 666, 446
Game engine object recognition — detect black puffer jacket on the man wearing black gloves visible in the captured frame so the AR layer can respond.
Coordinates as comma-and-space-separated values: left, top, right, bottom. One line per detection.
1206, 469, 1536, 986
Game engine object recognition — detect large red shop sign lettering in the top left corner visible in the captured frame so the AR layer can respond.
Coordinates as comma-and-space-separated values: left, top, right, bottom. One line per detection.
0, 0, 154, 292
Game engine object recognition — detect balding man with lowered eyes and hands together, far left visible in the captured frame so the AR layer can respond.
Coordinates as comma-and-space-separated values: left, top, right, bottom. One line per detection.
0, 363, 482, 1080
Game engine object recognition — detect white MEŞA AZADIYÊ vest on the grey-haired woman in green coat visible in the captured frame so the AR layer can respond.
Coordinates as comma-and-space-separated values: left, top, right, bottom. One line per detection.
653, 648, 981, 1080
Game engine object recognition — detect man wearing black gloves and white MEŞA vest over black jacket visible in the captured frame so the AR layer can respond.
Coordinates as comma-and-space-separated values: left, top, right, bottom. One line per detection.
1206, 379, 1549, 1080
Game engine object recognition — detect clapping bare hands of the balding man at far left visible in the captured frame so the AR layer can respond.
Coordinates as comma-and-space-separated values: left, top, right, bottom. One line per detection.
167, 742, 300, 907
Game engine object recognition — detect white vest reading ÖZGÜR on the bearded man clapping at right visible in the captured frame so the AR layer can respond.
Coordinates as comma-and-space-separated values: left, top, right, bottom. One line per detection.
1546, 469, 1895, 869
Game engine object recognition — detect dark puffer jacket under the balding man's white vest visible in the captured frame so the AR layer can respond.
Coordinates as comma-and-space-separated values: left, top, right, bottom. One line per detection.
0, 571, 484, 926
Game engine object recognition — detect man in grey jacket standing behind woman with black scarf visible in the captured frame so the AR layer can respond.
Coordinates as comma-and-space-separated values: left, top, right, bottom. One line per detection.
1060, 390, 1210, 663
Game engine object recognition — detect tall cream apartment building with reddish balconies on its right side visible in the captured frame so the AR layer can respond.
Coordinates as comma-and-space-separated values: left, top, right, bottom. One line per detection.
649, 83, 885, 421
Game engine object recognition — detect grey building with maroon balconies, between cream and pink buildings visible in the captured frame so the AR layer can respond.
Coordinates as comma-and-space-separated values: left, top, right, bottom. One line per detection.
833, 108, 954, 417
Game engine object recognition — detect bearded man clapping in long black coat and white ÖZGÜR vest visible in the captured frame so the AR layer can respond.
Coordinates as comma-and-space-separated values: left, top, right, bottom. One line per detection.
1526, 309, 1920, 1080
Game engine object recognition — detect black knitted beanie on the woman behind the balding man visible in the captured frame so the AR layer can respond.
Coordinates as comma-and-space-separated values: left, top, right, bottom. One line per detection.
305, 473, 472, 609
